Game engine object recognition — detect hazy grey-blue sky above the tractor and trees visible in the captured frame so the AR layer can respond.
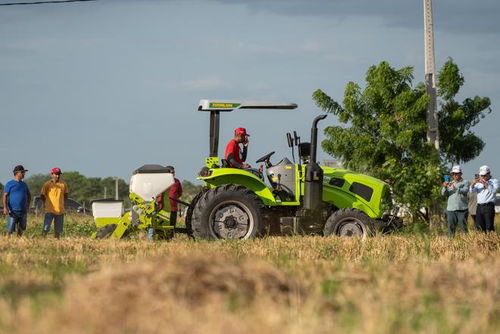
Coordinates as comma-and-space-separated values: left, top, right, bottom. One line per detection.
0, 0, 500, 183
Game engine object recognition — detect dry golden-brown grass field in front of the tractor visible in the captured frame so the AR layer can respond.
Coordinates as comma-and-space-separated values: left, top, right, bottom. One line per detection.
0, 217, 500, 334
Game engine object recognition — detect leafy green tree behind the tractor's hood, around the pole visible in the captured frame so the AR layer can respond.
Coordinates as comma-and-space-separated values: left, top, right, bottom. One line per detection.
313, 59, 489, 221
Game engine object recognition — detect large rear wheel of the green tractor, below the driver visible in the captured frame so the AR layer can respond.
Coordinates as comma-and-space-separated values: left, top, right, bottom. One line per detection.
191, 184, 264, 240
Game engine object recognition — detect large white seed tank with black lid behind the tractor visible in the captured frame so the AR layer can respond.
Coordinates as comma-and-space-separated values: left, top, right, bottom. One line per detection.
130, 165, 175, 201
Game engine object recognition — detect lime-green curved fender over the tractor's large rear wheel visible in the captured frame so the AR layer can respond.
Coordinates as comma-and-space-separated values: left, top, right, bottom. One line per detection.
198, 168, 276, 206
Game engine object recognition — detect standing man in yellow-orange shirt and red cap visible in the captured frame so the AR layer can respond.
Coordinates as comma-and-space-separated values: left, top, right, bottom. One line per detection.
40, 167, 69, 238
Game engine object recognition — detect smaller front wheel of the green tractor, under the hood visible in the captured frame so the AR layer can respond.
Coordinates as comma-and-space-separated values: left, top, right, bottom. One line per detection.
323, 209, 374, 239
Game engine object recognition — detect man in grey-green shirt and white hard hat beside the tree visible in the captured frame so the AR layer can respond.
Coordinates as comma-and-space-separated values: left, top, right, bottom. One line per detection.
441, 165, 470, 238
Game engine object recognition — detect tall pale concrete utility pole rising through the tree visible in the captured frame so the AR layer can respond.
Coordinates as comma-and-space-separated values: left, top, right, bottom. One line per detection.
424, 0, 439, 151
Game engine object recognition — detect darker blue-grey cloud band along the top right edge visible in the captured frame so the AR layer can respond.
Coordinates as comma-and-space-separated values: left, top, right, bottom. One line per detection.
212, 0, 500, 34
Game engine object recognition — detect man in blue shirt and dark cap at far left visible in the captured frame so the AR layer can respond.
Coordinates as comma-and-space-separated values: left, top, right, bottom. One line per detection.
3, 165, 31, 236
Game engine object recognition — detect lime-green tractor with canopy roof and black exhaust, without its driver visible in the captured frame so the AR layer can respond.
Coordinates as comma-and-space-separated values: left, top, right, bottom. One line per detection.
186, 100, 402, 240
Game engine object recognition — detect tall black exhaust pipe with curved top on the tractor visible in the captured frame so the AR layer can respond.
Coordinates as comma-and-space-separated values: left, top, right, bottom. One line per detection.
304, 115, 327, 211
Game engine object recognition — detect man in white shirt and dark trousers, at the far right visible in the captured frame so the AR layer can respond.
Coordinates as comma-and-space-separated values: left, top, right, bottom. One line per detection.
471, 166, 498, 233
